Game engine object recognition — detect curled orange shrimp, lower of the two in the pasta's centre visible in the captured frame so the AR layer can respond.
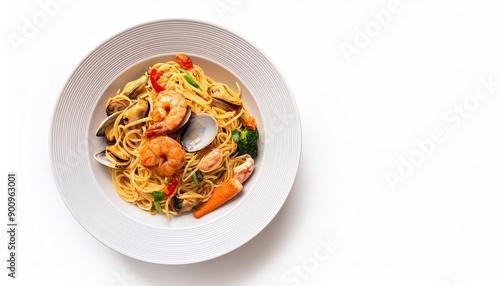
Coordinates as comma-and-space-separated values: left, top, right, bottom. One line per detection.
139, 136, 186, 177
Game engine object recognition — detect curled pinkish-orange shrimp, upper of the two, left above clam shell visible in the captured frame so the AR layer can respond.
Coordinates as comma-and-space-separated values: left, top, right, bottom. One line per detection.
144, 90, 188, 138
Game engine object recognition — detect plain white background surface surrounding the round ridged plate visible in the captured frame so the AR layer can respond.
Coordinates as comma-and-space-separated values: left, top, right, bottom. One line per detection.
0, 0, 500, 286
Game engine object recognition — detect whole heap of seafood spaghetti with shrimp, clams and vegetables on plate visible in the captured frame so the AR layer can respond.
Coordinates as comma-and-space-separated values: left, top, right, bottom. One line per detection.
94, 54, 259, 219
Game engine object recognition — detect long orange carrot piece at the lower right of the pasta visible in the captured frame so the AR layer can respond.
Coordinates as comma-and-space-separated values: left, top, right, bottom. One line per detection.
193, 178, 243, 218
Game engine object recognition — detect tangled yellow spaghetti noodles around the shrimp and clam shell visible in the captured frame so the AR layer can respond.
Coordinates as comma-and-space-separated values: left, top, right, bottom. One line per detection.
101, 58, 254, 219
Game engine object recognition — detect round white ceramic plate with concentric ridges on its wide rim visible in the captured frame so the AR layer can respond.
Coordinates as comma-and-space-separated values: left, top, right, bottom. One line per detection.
50, 20, 301, 264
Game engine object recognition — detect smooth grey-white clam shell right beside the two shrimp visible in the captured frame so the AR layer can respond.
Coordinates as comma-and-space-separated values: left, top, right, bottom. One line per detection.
181, 113, 218, 152
